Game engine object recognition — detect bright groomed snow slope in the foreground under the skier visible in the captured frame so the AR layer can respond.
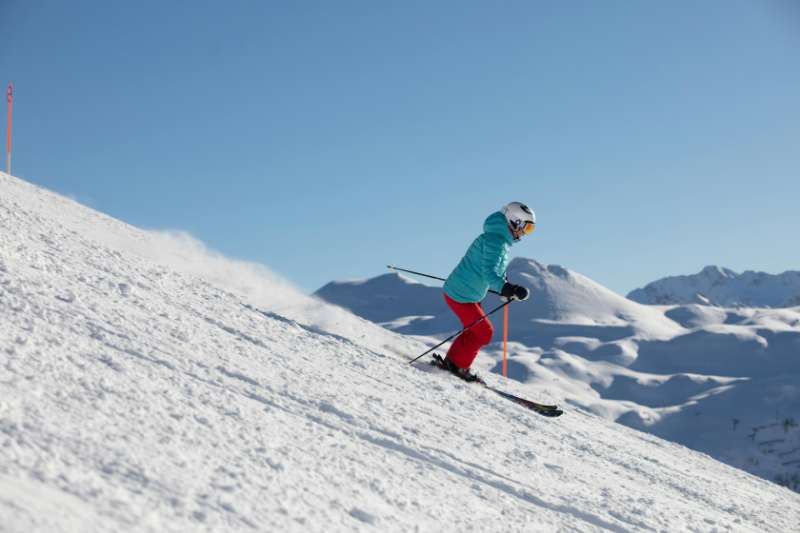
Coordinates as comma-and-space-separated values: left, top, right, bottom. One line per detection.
0, 174, 800, 532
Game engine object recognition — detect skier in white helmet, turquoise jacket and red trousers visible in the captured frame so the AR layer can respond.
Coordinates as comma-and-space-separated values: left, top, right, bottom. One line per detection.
435, 202, 536, 381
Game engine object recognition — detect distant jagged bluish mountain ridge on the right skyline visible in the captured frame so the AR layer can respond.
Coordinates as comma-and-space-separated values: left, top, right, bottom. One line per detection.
628, 266, 800, 308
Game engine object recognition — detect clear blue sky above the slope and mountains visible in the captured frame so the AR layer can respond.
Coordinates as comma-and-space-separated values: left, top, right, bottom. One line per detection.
0, 0, 800, 293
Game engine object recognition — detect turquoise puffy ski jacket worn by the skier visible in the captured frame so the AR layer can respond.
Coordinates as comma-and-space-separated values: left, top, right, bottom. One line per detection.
444, 211, 514, 303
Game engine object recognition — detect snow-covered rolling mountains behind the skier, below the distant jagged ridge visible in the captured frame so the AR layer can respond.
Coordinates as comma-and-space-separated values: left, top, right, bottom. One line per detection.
317, 258, 800, 489
